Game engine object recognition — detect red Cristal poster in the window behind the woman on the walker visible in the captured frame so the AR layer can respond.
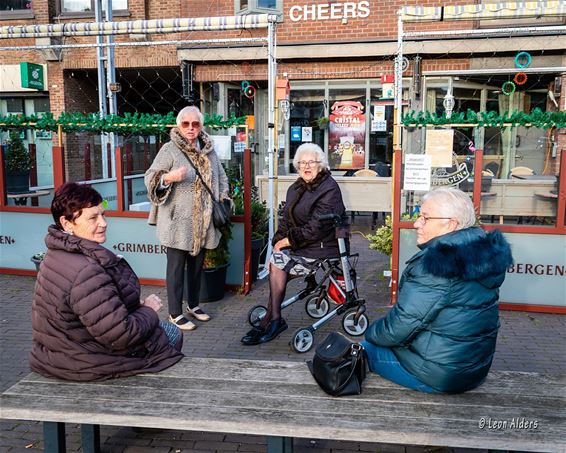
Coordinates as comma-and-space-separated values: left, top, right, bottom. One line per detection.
328, 101, 366, 170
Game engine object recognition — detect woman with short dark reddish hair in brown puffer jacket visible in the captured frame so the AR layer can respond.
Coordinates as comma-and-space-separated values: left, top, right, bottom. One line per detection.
30, 183, 183, 381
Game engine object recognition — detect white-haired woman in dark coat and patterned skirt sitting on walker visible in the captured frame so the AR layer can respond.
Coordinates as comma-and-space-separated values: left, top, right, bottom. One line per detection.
241, 143, 345, 345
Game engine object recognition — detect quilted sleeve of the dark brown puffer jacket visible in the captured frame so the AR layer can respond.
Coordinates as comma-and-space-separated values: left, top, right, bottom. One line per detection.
69, 265, 159, 350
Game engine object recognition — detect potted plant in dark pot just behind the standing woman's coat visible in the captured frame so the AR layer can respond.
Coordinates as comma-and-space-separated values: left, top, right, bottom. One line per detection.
199, 224, 232, 302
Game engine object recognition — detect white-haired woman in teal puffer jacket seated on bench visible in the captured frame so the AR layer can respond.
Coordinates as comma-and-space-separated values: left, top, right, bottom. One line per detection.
362, 188, 512, 393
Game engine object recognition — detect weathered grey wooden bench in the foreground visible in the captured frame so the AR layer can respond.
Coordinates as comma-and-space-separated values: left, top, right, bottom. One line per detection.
0, 358, 566, 453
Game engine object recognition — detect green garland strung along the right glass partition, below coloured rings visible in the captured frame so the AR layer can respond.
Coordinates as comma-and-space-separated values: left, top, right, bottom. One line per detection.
402, 108, 566, 129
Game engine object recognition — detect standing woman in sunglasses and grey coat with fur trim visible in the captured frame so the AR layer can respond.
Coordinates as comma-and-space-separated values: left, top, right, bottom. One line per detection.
145, 106, 228, 330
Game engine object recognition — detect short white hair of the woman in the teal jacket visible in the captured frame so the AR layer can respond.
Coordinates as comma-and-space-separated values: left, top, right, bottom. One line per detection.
422, 187, 476, 230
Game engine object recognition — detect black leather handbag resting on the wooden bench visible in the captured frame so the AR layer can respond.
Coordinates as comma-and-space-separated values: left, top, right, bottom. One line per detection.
307, 332, 367, 396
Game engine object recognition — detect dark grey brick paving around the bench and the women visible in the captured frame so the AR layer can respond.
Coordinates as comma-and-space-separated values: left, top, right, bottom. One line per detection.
0, 218, 566, 453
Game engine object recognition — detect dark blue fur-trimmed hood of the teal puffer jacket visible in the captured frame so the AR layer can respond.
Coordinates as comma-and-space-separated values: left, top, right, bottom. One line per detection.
418, 227, 513, 286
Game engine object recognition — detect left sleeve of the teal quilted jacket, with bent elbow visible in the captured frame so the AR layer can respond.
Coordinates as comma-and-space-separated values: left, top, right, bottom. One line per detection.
365, 262, 451, 347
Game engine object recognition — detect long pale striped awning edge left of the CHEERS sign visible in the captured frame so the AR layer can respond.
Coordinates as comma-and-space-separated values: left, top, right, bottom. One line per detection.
0, 14, 276, 39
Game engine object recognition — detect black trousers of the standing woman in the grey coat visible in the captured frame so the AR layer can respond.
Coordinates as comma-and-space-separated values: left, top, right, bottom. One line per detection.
166, 247, 204, 317
